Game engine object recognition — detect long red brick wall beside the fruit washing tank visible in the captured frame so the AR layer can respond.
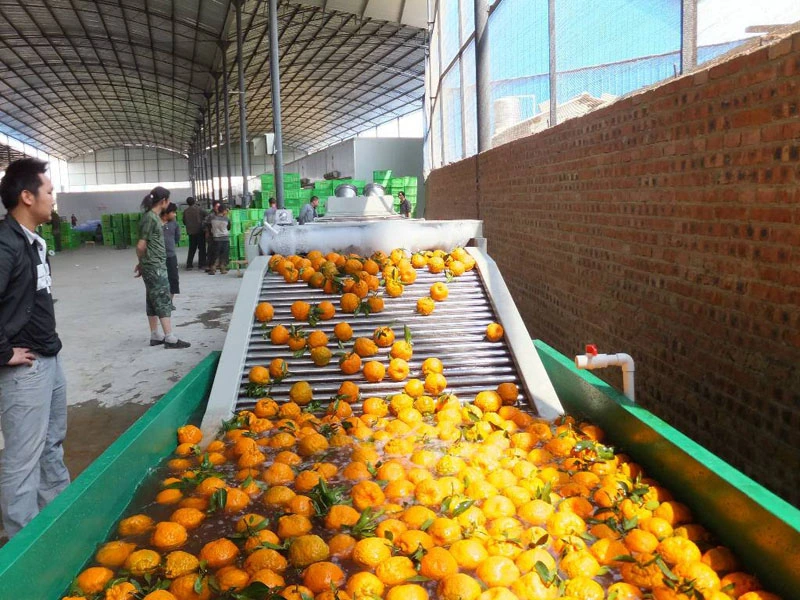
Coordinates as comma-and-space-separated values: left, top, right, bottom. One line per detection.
426, 34, 800, 505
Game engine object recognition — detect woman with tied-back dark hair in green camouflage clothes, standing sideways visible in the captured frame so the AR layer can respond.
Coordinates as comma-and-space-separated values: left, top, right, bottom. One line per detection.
134, 186, 191, 348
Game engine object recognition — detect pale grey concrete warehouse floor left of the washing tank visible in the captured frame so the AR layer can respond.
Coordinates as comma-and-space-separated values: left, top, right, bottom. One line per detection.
0, 246, 242, 478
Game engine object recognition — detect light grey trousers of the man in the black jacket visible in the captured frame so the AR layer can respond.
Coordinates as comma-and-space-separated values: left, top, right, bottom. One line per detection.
0, 356, 69, 537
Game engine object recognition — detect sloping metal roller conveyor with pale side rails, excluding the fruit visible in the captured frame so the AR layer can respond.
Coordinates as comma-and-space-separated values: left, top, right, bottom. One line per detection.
203, 248, 563, 438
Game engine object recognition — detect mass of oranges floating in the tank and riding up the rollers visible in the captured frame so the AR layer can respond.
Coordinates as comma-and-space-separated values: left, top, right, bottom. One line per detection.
68, 251, 777, 600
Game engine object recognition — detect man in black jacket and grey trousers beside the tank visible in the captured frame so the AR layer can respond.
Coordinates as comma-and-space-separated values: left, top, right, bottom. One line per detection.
0, 158, 69, 537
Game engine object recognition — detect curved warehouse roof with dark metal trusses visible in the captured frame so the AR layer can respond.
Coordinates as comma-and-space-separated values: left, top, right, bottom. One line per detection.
0, 0, 427, 158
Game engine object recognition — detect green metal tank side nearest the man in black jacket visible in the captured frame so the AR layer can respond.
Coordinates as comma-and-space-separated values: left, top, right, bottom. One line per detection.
0, 352, 219, 600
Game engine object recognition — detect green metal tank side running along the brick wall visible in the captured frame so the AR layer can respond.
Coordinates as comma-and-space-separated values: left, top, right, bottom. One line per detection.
534, 340, 800, 598
